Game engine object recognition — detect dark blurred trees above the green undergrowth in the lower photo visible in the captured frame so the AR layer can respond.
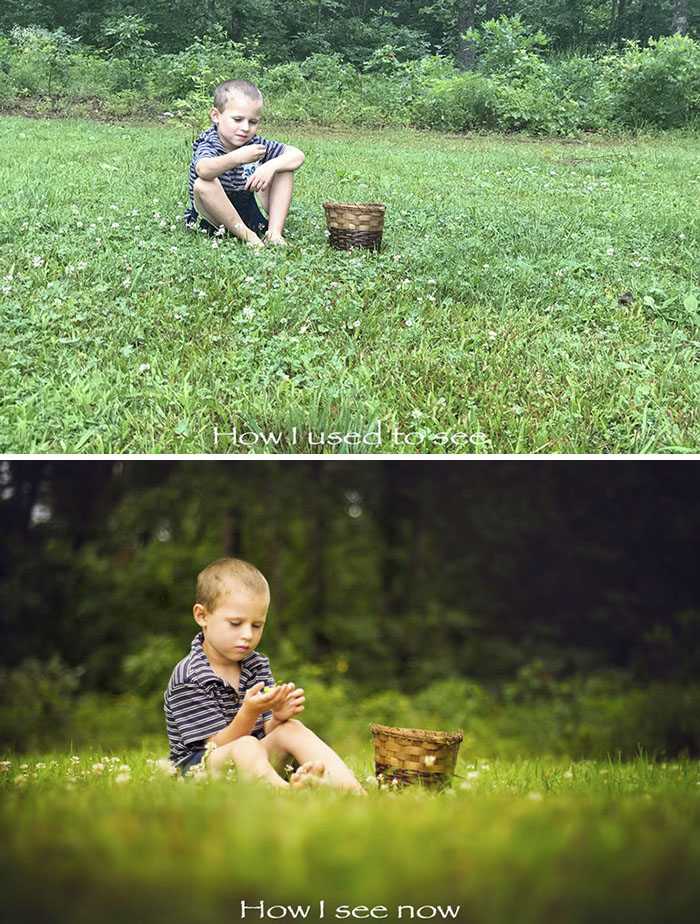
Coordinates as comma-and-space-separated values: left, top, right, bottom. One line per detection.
0, 460, 700, 692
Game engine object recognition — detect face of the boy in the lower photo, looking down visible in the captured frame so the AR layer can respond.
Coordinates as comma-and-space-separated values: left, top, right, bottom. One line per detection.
193, 586, 270, 665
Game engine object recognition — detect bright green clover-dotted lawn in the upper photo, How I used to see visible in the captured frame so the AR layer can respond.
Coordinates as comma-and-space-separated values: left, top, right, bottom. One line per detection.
0, 117, 700, 454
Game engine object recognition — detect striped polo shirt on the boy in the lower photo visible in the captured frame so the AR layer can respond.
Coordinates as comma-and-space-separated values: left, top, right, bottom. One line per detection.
163, 632, 275, 764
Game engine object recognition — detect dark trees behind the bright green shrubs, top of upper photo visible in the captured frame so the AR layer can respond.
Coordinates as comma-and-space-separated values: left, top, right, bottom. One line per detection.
0, 0, 700, 67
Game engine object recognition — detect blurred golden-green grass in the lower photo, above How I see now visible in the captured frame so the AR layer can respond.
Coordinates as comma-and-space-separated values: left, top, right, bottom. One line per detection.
0, 750, 700, 924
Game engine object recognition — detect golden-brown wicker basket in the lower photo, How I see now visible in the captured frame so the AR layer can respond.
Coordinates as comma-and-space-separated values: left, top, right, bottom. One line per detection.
370, 725, 463, 787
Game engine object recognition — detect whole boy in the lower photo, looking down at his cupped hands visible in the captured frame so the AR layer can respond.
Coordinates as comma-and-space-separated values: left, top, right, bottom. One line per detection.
165, 558, 364, 793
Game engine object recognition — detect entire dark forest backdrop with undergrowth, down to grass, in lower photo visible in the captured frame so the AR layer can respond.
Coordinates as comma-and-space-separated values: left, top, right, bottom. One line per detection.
0, 460, 700, 754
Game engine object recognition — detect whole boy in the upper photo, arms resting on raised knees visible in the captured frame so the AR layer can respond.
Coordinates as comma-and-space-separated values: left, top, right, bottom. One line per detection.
185, 80, 304, 247
